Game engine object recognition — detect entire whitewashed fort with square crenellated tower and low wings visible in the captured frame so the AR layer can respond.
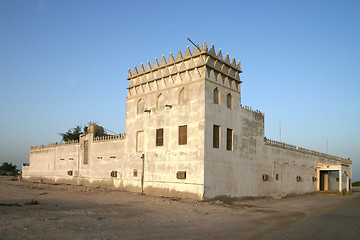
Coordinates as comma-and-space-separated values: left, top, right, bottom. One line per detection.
22, 43, 352, 200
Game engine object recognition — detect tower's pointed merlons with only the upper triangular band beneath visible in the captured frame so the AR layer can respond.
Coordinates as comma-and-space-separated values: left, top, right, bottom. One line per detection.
127, 42, 242, 89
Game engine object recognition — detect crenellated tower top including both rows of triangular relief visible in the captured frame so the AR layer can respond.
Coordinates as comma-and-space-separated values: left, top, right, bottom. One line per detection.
127, 42, 242, 96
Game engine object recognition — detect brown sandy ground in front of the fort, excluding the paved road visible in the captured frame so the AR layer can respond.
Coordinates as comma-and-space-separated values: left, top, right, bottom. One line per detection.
0, 177, 360, 239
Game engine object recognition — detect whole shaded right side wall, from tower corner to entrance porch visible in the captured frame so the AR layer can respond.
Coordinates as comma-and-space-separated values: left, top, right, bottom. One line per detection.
204, 79, 351, 198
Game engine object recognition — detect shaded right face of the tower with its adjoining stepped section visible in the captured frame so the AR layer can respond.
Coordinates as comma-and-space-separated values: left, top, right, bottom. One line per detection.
205, 89, 269, 198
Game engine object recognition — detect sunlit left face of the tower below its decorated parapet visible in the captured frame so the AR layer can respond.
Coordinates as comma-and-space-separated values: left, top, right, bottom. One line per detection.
126, 78, 205, 199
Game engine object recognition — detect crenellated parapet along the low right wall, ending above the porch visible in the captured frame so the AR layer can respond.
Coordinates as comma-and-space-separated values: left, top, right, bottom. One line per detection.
264, 137, 351, 164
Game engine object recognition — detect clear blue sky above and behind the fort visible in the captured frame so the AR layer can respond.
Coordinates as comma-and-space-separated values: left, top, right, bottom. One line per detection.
0, 0, 360, 181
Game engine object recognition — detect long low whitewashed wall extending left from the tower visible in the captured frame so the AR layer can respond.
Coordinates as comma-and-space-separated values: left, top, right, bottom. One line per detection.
23, 137, 140, 191
